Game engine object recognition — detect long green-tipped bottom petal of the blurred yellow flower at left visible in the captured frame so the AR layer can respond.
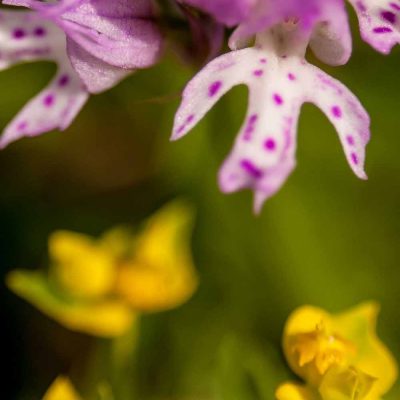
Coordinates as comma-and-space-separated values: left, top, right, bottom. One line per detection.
7, 271, 135, 337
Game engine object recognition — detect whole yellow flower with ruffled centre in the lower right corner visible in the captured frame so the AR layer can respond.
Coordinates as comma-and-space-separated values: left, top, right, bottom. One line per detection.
276, 302, 398, 400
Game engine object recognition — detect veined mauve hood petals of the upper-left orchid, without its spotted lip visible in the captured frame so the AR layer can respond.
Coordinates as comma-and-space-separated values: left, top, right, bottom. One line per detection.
3, 0, 162, 93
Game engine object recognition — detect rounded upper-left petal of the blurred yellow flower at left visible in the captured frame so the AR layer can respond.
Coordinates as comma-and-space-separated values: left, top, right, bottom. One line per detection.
49, 231, 116, 298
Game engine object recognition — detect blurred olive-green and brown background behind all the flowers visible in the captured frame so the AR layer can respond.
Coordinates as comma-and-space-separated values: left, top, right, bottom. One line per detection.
0, 17, 400, 400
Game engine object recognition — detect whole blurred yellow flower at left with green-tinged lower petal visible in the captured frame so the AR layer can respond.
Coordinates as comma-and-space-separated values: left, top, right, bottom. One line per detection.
7, 203, 197, 337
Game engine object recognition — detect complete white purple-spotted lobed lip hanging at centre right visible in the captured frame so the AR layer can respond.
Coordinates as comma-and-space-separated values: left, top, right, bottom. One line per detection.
172, 26, 370, 212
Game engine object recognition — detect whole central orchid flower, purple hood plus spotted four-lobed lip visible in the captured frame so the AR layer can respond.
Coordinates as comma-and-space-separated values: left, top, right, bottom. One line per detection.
172, 0, 369, 212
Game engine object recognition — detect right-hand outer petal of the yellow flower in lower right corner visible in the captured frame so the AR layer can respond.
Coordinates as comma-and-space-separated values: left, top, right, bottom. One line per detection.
332, 302, 398, 400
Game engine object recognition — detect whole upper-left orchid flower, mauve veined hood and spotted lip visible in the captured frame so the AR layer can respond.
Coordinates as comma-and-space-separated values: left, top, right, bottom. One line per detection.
0, 0, 162, 147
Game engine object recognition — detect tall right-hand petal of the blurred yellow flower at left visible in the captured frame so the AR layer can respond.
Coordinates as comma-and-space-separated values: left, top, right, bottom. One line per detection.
116, 203, 197, 311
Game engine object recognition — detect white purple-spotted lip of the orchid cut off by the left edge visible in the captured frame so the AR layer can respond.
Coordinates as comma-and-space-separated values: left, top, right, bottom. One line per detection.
0, 11, 89, 148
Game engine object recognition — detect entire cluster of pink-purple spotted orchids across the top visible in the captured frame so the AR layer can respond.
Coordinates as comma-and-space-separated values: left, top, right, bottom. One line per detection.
0, 0, 400, 211
